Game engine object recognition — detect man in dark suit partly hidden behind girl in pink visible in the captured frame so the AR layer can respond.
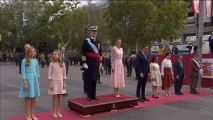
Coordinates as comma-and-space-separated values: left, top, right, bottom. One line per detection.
60, 46, 69, 95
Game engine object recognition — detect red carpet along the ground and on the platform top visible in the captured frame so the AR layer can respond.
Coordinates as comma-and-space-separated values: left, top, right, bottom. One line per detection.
5, 91, 212, 120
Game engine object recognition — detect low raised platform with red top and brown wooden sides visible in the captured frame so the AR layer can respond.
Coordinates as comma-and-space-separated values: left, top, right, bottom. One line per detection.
68, 94, 138, 117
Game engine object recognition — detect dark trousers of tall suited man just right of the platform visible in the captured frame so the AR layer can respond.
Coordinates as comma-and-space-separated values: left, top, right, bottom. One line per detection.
136, 74, 147, 99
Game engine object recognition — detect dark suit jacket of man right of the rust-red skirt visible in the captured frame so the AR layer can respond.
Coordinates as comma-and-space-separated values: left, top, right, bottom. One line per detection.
173, 60, 184, 77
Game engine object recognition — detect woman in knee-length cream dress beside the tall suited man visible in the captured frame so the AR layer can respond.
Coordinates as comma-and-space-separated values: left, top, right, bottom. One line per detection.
149, 56, 162, 98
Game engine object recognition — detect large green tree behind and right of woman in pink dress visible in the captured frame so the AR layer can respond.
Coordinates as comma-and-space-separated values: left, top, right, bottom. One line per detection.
106, 0, 188, 47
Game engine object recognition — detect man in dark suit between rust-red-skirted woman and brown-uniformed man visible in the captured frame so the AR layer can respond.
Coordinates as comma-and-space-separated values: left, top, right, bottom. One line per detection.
173, 55, 184, 95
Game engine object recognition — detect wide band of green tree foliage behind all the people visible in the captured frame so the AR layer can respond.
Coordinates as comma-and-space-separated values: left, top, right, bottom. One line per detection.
0, 0, 188, 51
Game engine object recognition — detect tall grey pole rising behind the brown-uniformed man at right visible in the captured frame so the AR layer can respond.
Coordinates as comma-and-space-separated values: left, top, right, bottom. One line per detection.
197, 0, 205, 87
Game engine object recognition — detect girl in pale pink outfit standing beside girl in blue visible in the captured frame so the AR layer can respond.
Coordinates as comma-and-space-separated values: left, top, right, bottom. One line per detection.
48, 50, 67, 118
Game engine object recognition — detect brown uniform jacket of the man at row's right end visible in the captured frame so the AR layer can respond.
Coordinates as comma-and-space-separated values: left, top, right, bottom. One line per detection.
189, 58, 200, 77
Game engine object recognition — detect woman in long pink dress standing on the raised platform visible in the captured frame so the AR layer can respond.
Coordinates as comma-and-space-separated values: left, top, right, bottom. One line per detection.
111, 39, 125, 97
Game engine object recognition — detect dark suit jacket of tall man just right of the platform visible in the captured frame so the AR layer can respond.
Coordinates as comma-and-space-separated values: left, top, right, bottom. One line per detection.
136, 51, 149, 77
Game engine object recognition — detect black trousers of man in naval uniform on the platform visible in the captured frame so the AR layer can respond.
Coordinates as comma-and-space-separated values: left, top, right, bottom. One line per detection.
86, 81, 96, 99
